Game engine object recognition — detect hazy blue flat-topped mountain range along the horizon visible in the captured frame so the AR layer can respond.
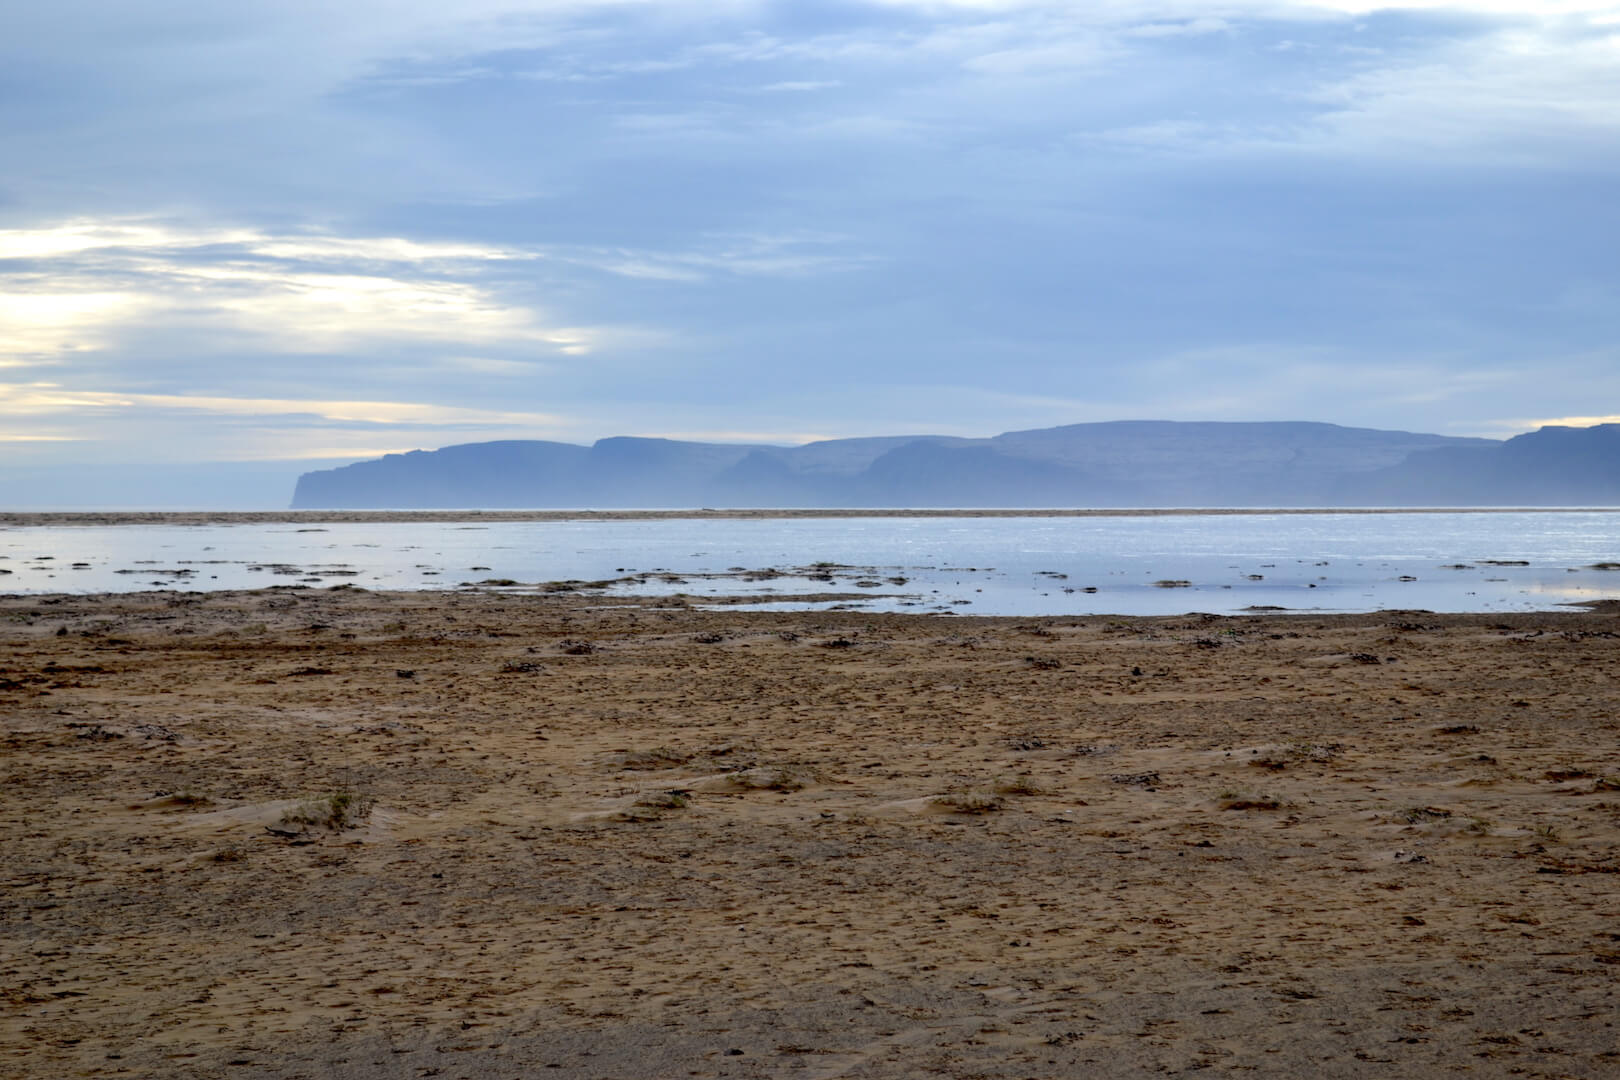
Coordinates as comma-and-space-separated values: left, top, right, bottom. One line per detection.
281, 421, 1620, 510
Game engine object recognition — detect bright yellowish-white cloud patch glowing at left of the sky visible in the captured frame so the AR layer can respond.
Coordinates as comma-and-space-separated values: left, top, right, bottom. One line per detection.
0, 220, 868, 371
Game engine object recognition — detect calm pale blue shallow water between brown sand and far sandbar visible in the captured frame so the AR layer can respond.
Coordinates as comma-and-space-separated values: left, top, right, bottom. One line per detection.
0, 512, 1620, 615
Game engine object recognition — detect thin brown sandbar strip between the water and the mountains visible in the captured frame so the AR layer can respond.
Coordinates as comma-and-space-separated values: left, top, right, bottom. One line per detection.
0, 507, 1620, 528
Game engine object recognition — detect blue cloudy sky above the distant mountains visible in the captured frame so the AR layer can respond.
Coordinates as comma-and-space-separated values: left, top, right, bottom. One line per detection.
0, 0, 1620, 497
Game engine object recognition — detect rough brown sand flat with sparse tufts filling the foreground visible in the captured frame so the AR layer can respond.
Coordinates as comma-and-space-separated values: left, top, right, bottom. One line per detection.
0, 589, 1620, 1078
